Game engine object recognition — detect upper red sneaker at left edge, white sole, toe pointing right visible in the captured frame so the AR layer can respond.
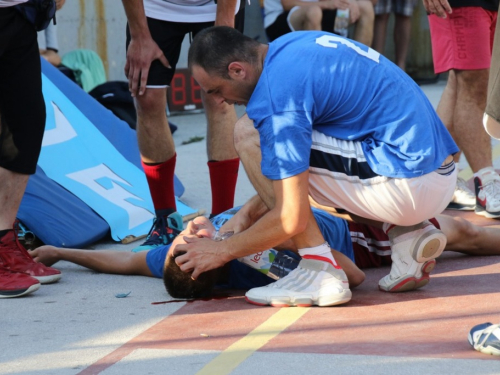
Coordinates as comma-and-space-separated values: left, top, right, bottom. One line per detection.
0, 230, 61, 284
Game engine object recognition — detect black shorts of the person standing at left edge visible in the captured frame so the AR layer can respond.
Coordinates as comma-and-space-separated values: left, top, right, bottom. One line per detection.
0, 7, 45, 174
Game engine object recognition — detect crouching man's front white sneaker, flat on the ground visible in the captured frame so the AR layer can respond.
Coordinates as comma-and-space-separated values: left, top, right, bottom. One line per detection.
245, 259, 352, 307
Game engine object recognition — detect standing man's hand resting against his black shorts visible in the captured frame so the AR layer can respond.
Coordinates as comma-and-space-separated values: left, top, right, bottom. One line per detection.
125, 37, 170, 96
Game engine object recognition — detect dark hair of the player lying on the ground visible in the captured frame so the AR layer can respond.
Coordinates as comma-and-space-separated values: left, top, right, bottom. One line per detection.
163, 253, 220, 298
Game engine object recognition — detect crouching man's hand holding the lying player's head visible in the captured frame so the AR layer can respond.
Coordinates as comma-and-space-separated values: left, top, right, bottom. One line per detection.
173, 236, 231, 280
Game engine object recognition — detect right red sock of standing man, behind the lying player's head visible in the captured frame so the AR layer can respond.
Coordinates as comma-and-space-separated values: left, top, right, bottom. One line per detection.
207, 158, 240, 215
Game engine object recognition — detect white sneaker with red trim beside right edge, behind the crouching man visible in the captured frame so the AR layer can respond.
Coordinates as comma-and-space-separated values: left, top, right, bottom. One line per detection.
474, 168, 500, 219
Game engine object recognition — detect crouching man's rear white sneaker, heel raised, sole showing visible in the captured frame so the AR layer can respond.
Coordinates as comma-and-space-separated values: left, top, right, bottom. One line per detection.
378, 220, 446, 292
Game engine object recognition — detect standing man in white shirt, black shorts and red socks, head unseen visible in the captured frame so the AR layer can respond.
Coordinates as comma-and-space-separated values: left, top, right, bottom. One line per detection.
122, 0, 244, 251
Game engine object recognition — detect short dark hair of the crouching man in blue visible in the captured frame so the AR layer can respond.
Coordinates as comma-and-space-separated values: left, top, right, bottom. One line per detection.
188, 26, 260, 79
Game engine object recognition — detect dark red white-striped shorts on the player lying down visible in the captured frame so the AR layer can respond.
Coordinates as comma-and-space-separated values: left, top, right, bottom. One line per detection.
348, 219, 440, 269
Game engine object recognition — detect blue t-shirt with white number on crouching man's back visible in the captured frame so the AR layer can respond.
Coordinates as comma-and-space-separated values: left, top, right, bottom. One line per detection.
246, 31, 458, 180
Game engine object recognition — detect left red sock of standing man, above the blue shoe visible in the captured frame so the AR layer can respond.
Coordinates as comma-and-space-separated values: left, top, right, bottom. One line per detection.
142, 154, 177, 211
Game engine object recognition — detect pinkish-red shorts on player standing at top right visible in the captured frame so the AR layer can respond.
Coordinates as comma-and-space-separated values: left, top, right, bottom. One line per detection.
429, 7, 497, 74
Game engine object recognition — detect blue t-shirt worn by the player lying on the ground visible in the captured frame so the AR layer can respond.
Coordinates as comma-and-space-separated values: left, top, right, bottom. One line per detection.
146, 207, 354, 289
